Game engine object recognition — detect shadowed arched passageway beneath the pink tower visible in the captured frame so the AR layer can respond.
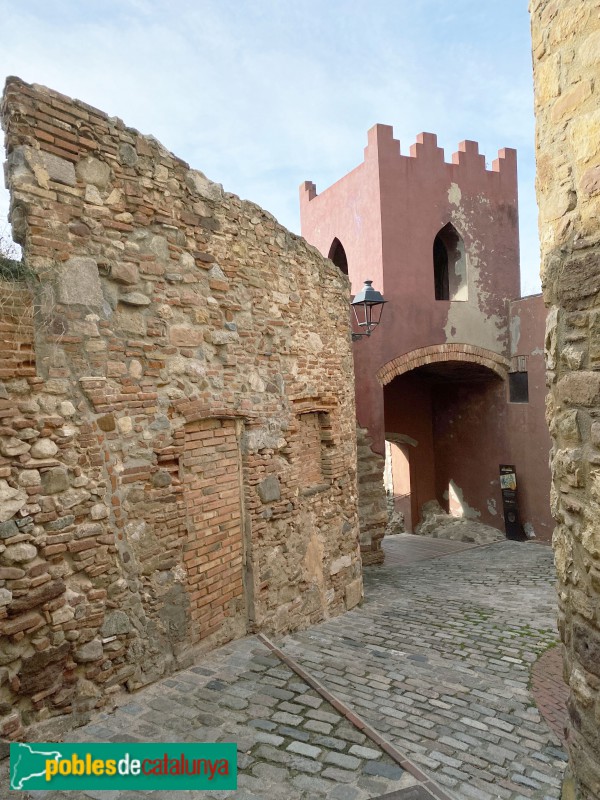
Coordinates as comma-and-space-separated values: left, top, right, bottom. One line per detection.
380, 346, 508, 529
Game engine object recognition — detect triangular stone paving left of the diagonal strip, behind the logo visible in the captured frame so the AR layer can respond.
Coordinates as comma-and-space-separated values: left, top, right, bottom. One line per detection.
0, 637, 431, 800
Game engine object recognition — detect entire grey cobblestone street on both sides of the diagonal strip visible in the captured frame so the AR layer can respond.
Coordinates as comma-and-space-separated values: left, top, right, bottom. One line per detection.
0, 537, 565, 800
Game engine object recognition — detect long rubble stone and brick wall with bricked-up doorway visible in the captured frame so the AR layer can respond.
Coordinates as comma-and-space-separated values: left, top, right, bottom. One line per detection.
0, 78, 362, 738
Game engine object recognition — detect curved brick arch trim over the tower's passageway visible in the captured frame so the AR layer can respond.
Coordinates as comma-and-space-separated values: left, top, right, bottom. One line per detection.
377, 343, 510, 386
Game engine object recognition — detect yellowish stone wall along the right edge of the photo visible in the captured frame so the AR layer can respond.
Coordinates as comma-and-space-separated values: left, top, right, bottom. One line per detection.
530, 0, 600, 800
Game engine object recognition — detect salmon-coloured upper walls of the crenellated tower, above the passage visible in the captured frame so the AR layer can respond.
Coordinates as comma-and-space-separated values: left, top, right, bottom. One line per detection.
300, 125, 519, 454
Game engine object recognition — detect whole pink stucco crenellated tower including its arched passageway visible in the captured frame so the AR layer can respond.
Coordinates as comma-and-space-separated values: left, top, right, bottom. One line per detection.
300, 125, 551, 561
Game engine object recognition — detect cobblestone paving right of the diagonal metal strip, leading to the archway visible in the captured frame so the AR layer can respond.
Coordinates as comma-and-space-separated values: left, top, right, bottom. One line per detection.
278, 537, 566, 800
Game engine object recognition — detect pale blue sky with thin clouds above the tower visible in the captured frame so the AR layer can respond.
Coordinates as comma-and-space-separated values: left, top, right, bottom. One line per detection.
0, 0, 540, 294
